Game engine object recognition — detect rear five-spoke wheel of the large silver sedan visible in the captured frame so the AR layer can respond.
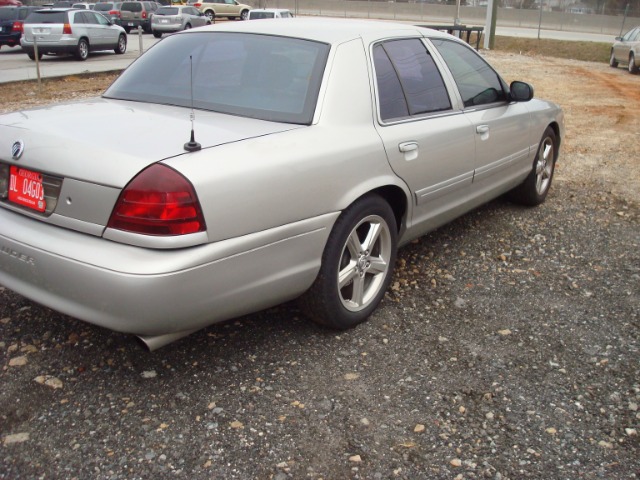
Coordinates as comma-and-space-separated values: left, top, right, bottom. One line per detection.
301, 194, 398, 330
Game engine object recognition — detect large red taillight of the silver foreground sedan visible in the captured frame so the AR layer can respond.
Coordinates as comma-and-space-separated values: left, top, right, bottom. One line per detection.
107, 164, 206, 236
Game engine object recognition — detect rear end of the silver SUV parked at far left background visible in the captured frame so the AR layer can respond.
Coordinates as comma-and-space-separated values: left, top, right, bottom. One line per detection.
20, 8, 78, 57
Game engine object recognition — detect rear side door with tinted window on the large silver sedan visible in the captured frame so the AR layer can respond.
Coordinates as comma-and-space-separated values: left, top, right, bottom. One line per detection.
372, 38, 475, 231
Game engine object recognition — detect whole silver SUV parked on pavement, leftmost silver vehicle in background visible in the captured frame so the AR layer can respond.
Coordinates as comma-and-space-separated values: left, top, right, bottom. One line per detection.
20, 8, 127, 60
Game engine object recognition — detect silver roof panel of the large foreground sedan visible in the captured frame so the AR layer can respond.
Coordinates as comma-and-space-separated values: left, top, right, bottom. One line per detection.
185, 17, 452, 44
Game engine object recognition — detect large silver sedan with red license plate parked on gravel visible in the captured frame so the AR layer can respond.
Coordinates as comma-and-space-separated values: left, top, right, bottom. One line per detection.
0, 19, 564, 348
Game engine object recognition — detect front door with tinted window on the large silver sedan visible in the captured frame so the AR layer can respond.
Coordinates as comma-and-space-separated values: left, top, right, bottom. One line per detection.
431, 39, 540, 194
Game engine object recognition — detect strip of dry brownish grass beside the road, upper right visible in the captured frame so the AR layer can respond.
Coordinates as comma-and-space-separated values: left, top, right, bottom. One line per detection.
495, 36, 613, 63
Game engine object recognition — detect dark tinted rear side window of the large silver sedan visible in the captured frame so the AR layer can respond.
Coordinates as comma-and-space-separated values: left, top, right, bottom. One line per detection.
373, 39, 451, 120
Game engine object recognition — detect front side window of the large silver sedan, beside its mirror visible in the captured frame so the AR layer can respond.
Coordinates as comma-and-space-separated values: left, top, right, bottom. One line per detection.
431, 39, 507, 107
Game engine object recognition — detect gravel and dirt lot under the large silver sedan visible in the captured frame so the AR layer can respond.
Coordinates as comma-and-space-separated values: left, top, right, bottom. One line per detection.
0, 52, 640, 480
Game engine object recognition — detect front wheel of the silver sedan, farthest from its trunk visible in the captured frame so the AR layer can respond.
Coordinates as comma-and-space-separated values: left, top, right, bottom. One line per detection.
509, 127, 558, 207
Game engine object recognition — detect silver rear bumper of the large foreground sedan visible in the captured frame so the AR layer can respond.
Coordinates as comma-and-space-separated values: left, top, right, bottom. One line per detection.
0, 209, 338, 335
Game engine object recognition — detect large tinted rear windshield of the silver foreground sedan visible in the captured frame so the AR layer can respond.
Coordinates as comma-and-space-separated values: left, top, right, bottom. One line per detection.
104, 32, 329, 125
